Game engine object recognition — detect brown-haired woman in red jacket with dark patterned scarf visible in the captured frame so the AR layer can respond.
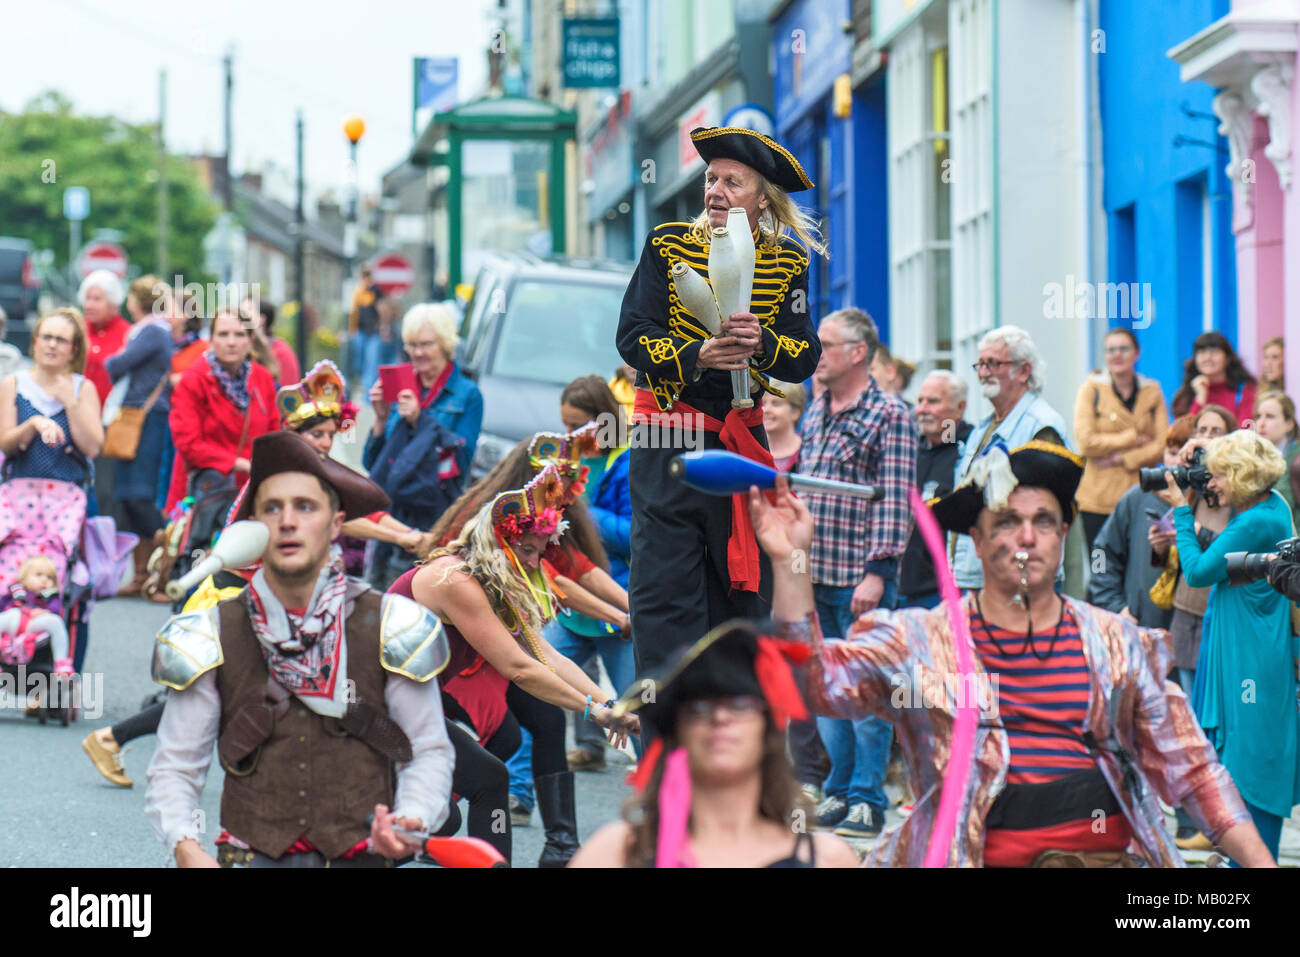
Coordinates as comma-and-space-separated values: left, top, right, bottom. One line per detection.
166, 311, 280, 511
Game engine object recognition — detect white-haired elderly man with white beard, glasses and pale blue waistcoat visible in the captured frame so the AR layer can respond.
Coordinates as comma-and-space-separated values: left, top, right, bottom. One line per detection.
948, 325, 1074, 590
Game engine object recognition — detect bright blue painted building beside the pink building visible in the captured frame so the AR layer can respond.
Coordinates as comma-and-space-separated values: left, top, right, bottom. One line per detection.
1092, 0, 1236, 400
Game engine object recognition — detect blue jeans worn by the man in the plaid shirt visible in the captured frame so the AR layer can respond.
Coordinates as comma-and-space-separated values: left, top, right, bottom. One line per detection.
813, 581, 897, 814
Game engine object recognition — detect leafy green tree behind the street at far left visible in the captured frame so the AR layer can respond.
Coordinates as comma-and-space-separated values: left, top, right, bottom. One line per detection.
0, 91, 217, 282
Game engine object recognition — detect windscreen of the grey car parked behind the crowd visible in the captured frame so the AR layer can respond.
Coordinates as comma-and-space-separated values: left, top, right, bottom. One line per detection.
491, 280, 624, 385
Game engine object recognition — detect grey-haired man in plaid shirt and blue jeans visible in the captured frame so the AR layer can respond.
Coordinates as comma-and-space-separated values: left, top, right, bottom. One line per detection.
798, 308, 917, 837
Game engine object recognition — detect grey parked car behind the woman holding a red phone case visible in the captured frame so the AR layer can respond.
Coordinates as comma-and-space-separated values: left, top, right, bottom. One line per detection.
458, 256, 633, 479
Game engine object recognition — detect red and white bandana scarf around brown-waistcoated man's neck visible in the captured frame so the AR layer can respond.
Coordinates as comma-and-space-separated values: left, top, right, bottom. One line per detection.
244, 558, 348, 718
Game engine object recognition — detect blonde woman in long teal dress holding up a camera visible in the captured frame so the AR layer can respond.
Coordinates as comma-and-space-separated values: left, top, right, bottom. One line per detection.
1166, 430, 1300, 857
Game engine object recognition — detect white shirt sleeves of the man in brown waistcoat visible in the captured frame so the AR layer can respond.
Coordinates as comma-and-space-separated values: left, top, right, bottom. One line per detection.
144, 670, 456, 850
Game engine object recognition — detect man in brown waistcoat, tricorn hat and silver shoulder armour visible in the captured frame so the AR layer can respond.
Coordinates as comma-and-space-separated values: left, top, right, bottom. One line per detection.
146, 432, 454, 867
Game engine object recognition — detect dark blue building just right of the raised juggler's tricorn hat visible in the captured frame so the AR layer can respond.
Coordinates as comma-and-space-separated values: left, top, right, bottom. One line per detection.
772, 0, 889, 342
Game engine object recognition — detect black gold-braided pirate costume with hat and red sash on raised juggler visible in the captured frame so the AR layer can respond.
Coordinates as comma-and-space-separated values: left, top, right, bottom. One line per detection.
618, 127, 822, 696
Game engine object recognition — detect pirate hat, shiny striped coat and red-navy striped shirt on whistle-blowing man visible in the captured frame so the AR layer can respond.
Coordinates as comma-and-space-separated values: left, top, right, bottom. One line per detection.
781, 441, 1249, 867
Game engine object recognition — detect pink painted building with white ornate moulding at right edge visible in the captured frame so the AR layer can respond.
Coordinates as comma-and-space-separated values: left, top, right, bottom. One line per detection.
1169, 0, 1300, 397
